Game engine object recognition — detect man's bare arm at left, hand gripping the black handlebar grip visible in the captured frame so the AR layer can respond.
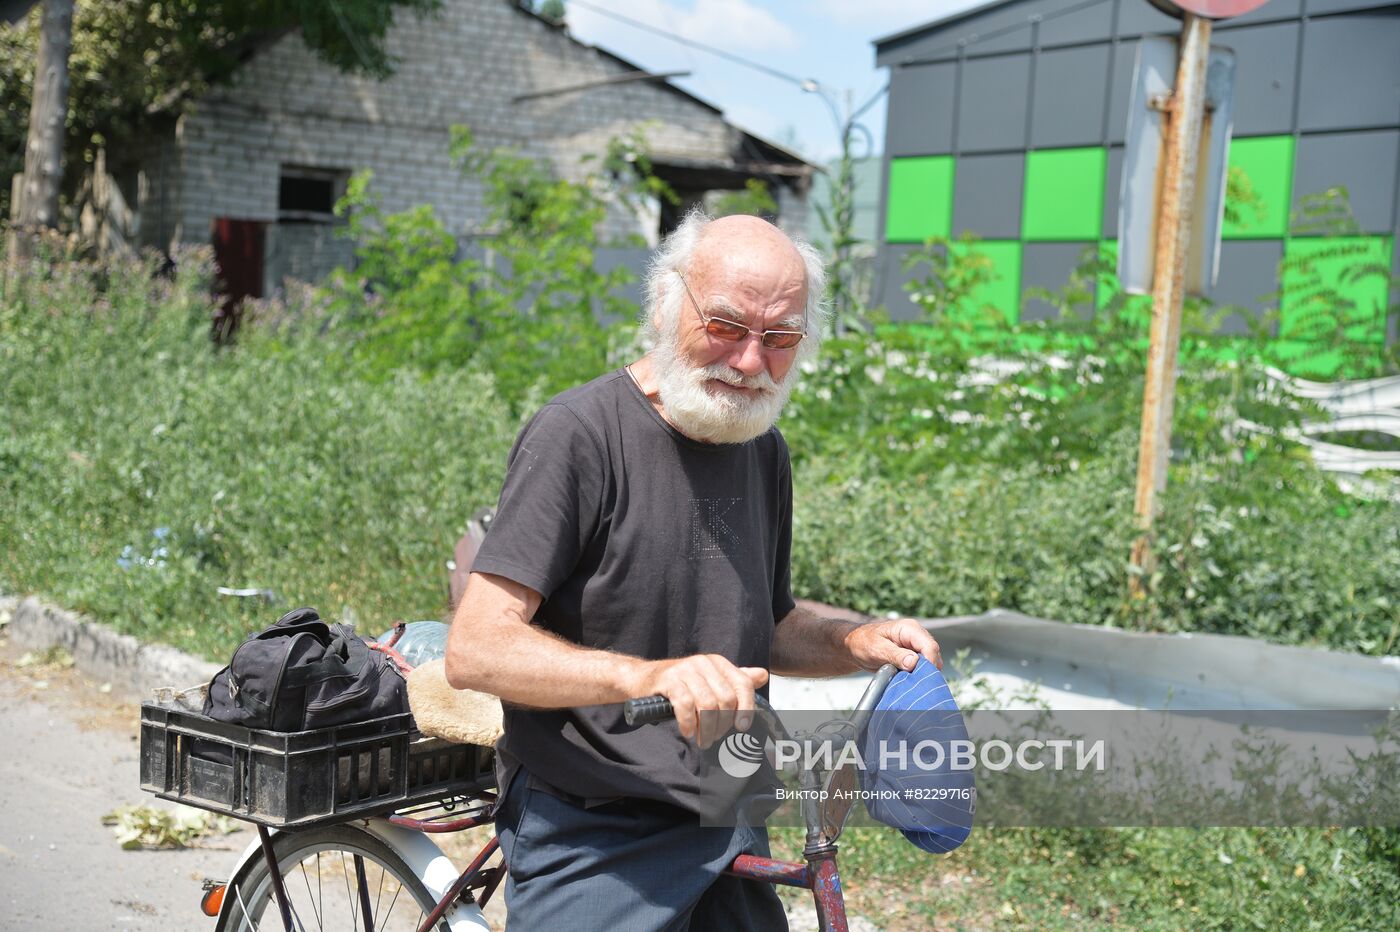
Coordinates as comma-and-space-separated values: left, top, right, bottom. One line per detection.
445, 572, 769, 746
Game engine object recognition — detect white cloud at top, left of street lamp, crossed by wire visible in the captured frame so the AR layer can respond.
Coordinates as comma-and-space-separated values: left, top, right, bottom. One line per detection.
567, 0, 799, 52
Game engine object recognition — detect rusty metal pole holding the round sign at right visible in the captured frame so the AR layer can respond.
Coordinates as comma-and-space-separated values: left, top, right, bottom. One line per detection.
1130, 13, 1211, 596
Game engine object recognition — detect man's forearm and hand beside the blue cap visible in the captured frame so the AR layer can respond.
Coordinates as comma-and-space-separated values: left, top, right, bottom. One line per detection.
773, 606, 944, 676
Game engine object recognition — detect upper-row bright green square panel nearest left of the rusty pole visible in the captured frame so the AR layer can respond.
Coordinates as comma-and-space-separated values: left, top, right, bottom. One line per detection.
1021, 148, 1107, 241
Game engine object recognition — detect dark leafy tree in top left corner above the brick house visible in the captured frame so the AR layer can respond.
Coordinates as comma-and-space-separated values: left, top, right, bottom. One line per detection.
0, 0, 441, 217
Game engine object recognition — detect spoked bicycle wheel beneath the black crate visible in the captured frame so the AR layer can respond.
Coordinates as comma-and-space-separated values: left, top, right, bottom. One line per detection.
218, 826, 448, 932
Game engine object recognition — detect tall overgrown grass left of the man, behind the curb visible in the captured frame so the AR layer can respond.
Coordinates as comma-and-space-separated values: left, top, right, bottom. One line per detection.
0, 249, 517, 658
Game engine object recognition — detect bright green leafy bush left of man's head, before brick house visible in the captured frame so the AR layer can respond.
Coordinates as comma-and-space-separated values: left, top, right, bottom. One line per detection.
323, 126, 641, 410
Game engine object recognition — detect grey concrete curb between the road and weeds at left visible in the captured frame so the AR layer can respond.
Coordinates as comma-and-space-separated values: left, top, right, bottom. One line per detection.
0, 598, 220, 696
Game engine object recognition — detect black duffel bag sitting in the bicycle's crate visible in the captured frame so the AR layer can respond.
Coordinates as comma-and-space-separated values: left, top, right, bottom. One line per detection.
204, 609, 409, 732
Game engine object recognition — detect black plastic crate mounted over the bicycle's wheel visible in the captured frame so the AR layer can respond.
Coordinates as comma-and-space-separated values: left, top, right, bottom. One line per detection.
141, 702, 494, 826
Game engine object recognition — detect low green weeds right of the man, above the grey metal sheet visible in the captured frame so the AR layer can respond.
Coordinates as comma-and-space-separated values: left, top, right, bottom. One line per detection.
792, 434, 1400, 654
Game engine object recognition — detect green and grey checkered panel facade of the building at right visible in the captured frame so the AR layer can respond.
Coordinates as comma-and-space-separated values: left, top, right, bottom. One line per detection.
875, 0, 1400, 369
